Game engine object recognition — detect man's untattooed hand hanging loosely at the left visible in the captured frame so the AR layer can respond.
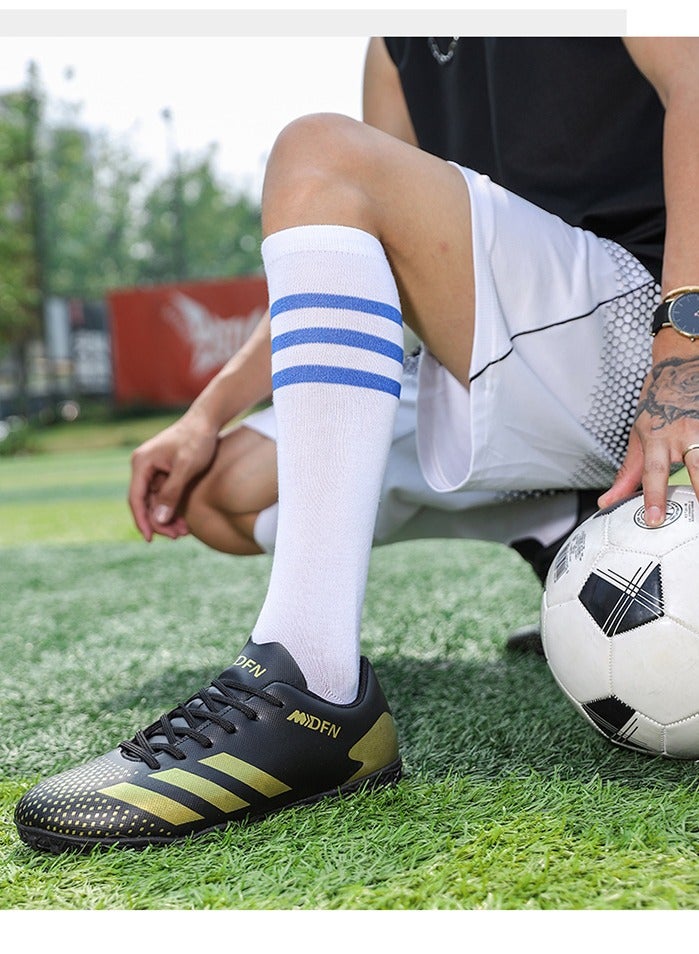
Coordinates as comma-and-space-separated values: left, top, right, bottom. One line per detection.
129, 412, 218, 543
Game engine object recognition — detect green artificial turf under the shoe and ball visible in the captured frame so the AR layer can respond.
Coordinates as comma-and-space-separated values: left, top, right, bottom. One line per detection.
0, 438, 699, 911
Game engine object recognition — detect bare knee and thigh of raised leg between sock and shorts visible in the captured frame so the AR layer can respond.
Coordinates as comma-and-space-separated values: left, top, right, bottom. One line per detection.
263, 114, 482, 385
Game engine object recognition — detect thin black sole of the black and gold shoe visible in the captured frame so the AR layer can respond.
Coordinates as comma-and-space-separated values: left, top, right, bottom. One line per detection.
17, 759, 403, 855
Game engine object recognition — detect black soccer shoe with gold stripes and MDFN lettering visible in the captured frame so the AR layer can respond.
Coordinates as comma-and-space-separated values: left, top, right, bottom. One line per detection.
15, 642, 401, 853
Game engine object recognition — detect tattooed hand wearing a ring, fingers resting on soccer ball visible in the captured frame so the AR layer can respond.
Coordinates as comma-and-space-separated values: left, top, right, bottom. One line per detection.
599, 329, 699, 527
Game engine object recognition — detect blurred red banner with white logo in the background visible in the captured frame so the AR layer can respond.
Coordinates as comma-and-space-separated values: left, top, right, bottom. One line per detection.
108, 278, 267, 408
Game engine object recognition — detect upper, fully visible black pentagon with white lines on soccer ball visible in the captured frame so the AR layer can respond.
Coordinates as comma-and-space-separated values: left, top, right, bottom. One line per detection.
578, 563, 663, 638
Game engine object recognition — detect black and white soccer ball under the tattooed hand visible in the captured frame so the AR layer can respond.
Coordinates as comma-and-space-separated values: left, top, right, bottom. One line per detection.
541, 486, 699, 759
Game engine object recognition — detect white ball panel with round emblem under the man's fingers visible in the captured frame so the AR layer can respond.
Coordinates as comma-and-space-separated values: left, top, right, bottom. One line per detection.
608, 486, 699, 557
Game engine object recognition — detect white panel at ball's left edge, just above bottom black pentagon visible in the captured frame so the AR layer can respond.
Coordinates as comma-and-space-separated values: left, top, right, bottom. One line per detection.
541, 600, 610, 702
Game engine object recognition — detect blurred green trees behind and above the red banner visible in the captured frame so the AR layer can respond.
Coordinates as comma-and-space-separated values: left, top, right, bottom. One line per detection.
0, 65, 261, 347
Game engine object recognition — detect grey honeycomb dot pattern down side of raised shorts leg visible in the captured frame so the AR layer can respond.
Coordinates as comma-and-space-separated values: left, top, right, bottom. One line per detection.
574, 239, 660, 489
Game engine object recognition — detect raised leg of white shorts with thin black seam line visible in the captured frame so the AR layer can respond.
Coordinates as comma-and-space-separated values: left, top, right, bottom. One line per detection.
417, 169, 659, 493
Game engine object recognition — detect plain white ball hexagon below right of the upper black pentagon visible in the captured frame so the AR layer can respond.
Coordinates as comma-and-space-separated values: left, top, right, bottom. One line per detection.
611, 616, 699, 724
